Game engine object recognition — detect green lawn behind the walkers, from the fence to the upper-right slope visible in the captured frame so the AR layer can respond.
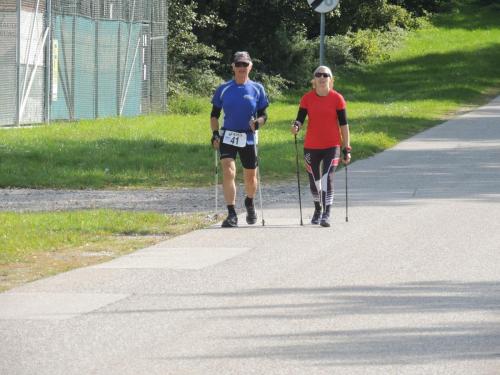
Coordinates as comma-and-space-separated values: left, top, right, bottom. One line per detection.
0, 0, 500, 188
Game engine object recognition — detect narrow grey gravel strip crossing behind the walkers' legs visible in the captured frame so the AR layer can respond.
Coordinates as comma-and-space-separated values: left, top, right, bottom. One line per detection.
0, 181, 304, 213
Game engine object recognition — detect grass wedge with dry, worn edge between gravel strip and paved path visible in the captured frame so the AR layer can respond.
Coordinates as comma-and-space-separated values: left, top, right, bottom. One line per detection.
0, 210, 215, 291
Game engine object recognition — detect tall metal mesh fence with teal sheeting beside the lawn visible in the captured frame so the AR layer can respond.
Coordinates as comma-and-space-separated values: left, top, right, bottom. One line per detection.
0, 0, 167, 126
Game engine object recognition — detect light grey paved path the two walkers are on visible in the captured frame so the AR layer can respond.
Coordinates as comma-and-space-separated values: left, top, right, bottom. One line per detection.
0, 98, 500, 375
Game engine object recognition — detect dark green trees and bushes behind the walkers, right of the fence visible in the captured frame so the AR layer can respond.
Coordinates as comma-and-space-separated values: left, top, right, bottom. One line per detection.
168, 0, 457, 96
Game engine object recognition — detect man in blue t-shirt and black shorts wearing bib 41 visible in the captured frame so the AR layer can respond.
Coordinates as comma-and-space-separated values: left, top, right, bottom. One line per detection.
210, 51, 269, 227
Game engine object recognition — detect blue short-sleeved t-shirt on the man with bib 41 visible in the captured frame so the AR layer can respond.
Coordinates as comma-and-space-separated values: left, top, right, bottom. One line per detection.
212, 79, 269, 144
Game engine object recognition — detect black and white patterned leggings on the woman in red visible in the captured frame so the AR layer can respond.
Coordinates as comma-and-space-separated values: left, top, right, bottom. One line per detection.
304, 146, 340, 208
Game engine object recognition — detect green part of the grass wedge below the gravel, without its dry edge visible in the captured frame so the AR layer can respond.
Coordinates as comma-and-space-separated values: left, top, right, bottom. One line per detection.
0, 210, 210, 264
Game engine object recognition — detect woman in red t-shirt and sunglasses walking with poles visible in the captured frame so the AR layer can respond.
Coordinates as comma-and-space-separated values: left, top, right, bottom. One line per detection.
291, 66, 351, 227
